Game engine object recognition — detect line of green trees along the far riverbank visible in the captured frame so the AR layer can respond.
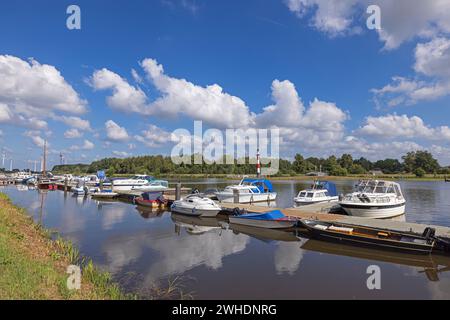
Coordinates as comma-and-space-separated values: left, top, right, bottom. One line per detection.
53, 151, 450, 177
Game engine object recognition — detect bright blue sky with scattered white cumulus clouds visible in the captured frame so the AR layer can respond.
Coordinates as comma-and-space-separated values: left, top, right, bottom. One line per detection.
0, 0, 450, 168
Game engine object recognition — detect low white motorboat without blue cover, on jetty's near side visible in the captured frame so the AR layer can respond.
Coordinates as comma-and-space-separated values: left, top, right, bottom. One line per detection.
170, 194, 222, 217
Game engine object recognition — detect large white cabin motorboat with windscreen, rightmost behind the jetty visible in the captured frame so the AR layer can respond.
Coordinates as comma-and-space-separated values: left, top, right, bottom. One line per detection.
339, 180, 406, 219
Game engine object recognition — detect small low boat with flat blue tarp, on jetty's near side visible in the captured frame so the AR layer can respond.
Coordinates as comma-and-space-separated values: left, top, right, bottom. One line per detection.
229, 210, 297, 229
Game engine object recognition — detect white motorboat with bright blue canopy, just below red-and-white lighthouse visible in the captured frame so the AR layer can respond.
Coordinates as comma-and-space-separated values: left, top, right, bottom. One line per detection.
216, 178, 277, 203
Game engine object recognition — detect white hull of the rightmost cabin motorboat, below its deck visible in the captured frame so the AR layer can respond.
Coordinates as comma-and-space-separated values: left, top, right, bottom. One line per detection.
340, 203, 405, 219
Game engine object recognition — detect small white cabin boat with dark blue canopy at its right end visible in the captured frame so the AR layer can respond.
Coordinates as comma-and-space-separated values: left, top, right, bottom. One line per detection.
294, 181, 339, 205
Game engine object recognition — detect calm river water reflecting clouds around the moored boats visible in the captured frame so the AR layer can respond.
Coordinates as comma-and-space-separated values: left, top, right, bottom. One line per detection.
0, 180, 450, 299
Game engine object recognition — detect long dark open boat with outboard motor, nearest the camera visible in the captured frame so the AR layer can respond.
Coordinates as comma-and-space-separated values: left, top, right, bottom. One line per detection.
299, 219, 448, 254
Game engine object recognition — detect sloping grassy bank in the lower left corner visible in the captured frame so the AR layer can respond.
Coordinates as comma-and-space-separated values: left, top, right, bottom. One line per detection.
0, 193, 127, 300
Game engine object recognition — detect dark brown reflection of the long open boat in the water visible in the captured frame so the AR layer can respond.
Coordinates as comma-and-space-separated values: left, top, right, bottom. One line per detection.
301, 236, 450, 281
